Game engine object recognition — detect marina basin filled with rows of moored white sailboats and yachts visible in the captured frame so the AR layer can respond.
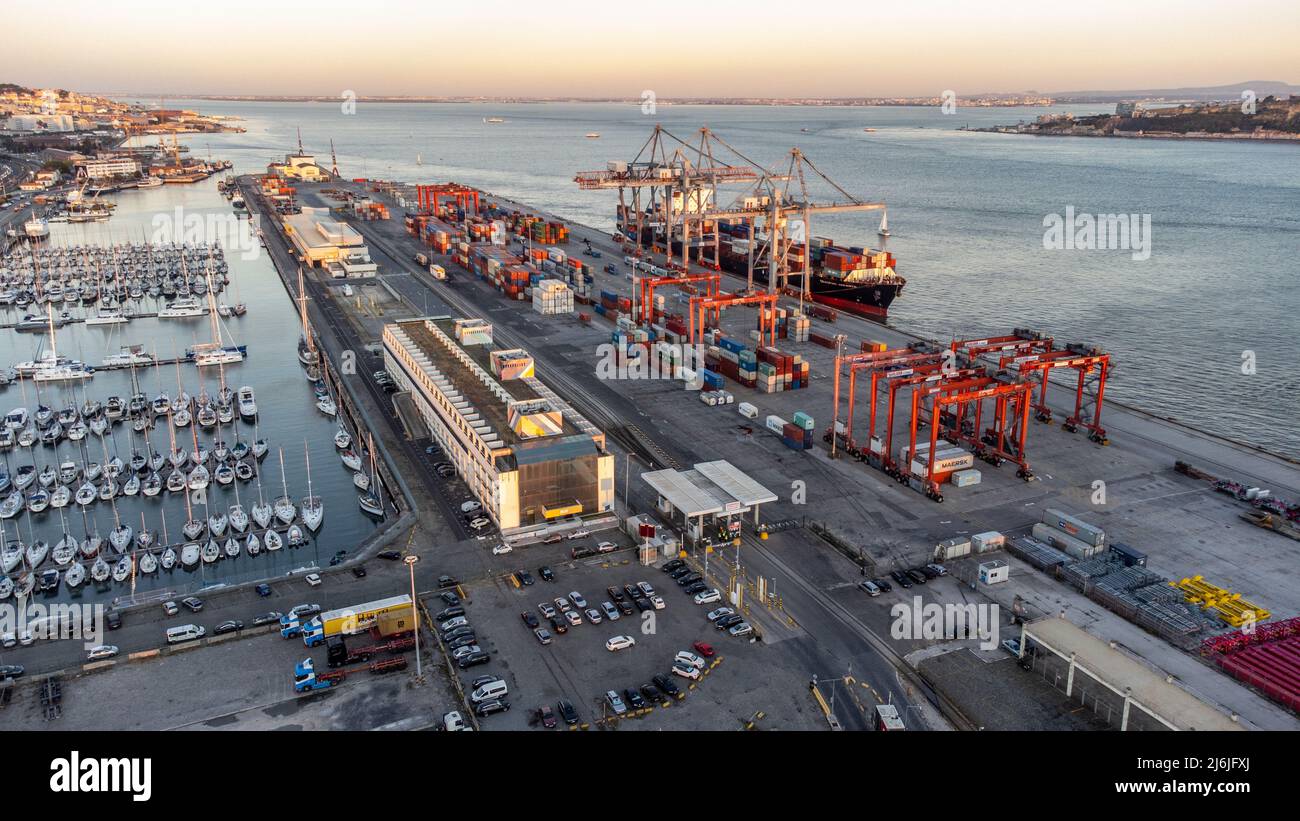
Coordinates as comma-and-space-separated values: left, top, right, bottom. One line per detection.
0, 182, 377, 600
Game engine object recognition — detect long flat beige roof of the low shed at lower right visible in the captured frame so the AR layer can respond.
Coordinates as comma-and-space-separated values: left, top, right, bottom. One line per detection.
1024, 617, 1245, 730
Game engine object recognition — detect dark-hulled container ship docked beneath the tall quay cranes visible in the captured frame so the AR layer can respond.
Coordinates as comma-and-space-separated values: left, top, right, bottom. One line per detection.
619, 210, 907, 321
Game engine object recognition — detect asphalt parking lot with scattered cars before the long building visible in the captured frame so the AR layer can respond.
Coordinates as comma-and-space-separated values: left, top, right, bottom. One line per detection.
430, 546, 826, 730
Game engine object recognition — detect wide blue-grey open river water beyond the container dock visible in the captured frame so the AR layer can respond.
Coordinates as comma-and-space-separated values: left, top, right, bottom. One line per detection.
131, 101, 1300, 455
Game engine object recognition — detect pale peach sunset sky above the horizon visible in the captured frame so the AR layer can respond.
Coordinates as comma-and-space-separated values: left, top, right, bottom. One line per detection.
10, 0, 1300, 97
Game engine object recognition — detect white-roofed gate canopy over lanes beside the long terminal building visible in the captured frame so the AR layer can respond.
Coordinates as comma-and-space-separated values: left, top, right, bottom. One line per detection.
641, 460, 776, 546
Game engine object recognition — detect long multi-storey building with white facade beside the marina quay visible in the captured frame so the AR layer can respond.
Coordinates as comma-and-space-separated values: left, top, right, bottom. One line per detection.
384, 317, 614, 535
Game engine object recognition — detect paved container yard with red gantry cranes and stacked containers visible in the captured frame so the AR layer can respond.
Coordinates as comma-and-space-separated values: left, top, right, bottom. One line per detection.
258, 149, 1300, 726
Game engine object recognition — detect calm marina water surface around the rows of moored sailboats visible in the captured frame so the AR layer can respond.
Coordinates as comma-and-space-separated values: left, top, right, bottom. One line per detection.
0, 177, 374, 599
